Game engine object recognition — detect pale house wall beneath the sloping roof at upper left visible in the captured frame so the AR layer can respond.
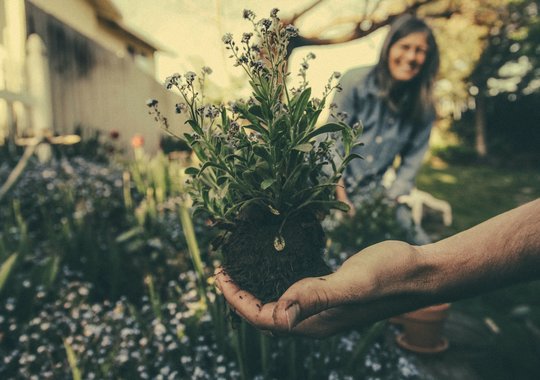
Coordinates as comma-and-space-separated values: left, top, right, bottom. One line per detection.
22, 0, 183, 151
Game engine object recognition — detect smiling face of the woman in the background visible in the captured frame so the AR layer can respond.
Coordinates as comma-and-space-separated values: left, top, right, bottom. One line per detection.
388, 32, 428, 82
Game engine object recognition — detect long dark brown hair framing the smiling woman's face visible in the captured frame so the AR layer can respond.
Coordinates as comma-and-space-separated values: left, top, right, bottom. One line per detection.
371, 14, 439, 122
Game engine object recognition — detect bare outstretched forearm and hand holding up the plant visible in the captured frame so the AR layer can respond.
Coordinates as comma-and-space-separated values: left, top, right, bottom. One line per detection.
216, 199, 540, 337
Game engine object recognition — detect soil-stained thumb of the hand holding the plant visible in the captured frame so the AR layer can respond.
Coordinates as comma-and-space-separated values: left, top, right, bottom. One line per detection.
272, 275, 338, 331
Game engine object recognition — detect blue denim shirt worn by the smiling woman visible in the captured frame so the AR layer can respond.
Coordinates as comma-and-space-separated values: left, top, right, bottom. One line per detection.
334, 67, 434, 199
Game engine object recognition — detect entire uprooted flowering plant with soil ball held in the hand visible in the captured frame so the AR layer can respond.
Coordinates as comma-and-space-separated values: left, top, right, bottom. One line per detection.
148, 9, 360, 302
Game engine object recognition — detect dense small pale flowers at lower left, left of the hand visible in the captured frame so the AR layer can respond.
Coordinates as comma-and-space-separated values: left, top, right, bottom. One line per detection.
0, 272, 240, 379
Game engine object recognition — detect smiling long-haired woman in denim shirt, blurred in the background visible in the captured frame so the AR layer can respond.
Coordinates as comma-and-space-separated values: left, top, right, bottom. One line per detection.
334, 15, 439, 244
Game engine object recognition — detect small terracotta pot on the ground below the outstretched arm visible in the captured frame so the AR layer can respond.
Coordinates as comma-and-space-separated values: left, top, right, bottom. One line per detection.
395, 303, 450, 354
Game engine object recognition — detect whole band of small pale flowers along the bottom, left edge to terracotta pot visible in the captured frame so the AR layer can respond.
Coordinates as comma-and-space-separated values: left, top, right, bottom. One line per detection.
0, 271, 418, 380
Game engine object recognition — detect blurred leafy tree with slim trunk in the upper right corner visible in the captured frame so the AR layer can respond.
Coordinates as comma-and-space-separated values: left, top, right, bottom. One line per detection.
468, 0, 540, 157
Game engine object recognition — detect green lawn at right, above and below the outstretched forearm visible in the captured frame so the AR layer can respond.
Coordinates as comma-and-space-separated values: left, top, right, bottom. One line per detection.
417, 164, 540, 380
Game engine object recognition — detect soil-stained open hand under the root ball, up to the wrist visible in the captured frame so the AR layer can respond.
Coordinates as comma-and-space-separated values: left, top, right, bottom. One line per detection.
216, 241, 423, 338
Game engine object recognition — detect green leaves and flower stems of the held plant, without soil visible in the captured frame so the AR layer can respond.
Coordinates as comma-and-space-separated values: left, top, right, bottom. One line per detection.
148, 10, 360, 229
